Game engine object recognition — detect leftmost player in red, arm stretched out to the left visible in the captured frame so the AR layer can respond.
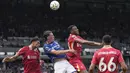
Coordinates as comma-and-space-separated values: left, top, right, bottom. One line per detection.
3, 38, 41, 73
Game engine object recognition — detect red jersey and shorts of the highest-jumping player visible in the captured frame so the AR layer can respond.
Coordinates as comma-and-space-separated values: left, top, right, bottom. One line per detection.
67, 34, 86, 72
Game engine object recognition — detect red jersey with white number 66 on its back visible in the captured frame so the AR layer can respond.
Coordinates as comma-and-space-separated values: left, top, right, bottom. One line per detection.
91, 48, 124, 73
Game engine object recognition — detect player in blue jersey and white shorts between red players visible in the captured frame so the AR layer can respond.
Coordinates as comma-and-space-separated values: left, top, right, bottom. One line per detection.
43, 30, 77, 73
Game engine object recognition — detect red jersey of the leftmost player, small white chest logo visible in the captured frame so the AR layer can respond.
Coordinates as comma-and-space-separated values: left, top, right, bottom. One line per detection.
18, 46, 41, 73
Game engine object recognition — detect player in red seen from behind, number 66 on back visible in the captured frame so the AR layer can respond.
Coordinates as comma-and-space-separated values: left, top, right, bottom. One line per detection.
89, 35, 127, 73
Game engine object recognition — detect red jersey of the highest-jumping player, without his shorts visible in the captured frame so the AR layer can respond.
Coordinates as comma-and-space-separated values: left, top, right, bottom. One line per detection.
67, 34, 82, 60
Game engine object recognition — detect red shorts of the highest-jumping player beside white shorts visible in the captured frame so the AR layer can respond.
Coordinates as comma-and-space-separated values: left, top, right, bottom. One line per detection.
69, 60, 86, 72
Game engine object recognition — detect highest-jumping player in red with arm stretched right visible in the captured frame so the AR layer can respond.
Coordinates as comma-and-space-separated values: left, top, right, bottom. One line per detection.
67, 25, 101, 73
